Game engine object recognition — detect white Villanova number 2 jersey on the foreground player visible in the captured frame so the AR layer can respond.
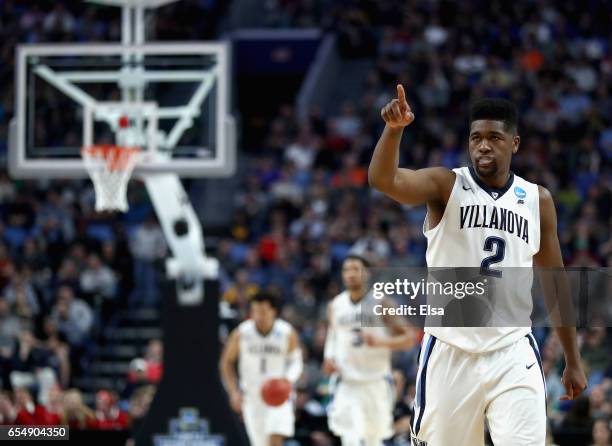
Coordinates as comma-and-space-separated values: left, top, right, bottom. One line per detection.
423, 167, 540, 353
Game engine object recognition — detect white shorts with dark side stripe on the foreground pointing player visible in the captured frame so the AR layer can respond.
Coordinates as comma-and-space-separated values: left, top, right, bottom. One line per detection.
412, 333, 546, 446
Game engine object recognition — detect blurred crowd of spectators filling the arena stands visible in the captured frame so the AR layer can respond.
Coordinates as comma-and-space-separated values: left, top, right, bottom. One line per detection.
0, 0, 612, 446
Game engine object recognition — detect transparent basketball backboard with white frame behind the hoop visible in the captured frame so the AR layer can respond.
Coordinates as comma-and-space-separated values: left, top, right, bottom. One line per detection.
9, 42, 236, 178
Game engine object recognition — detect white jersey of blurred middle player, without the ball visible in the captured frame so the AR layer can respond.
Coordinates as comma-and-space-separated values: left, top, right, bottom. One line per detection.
330, 291, 391, 382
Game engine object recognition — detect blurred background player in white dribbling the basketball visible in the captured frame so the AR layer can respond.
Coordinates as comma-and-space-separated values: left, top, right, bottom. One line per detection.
221, 291, 303, 446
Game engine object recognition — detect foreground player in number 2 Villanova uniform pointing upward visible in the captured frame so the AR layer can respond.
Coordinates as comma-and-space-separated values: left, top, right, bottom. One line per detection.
369, 85, 586, 446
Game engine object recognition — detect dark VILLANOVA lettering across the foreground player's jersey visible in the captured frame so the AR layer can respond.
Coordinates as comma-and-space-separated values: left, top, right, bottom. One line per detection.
459, 204, 529, 243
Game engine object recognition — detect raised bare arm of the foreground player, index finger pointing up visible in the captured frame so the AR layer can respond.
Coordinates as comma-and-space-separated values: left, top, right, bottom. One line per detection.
368, 84, 455, 206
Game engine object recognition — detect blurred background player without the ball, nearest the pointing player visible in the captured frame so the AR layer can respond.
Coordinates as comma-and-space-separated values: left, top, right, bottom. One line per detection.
323, 255, 414, 446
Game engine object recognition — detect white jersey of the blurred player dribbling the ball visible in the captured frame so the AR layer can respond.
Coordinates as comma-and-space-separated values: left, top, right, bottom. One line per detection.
238, 319, 292, 395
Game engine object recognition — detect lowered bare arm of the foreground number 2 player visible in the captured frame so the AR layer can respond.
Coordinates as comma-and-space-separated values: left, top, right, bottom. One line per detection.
533, 186, 586, 399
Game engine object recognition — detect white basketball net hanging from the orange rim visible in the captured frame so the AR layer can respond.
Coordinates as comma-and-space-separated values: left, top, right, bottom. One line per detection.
81, 144, 142, 212
